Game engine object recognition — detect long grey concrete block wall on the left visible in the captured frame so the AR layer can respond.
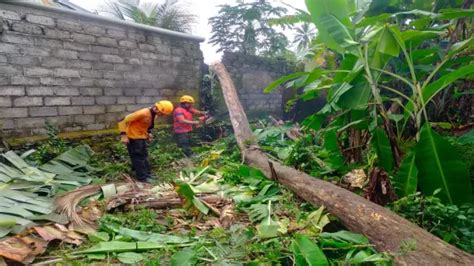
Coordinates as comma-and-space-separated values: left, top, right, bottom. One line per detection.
0, 4, 203, 136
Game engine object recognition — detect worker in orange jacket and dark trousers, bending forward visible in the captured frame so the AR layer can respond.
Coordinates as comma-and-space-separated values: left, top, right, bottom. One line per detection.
118, 101, 174, 182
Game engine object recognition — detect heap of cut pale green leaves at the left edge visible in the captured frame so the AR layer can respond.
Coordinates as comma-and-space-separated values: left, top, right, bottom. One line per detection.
0, 146, 94, 237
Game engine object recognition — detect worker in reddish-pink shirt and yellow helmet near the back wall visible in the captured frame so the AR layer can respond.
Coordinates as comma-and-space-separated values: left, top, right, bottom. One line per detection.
173, 95, 207, 157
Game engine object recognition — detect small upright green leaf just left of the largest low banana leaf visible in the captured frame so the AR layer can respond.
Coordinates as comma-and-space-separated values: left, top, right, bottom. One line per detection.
393, 153, 418, 198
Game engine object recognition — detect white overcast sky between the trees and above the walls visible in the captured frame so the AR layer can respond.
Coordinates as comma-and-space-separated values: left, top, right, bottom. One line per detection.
70, 0, 306, 63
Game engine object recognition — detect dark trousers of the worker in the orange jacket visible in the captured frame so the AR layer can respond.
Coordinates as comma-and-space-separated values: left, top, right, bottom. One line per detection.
127, 139, 151, 181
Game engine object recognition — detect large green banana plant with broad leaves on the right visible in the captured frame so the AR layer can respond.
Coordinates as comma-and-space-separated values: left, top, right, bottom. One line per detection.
267, 0, 474, 203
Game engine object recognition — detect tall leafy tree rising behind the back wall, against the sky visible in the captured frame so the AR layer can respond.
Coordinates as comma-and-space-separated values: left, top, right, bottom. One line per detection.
209, 1, 288, 56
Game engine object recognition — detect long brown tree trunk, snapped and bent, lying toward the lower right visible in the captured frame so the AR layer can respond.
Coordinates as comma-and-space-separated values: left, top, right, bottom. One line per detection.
213, 63, 474, 265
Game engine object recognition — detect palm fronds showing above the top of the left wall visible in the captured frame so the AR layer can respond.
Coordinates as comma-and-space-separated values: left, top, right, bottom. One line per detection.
102, 0, 196, 32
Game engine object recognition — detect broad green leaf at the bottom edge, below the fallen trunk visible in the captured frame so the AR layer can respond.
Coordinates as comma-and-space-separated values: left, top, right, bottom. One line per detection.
290, 234, 329, 266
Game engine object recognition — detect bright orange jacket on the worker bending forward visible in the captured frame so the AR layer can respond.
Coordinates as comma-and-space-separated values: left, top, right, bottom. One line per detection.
118, 108, 155, 139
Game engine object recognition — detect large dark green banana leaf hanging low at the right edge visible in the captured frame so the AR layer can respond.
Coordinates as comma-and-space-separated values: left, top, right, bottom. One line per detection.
416, 124, 472, 204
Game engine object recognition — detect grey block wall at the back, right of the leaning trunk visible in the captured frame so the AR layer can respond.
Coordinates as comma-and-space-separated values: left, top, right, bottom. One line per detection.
222, 52, 295, 116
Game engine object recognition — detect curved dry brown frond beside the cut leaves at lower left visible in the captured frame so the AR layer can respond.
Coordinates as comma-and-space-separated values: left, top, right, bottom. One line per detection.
54, 185, 101, 225
